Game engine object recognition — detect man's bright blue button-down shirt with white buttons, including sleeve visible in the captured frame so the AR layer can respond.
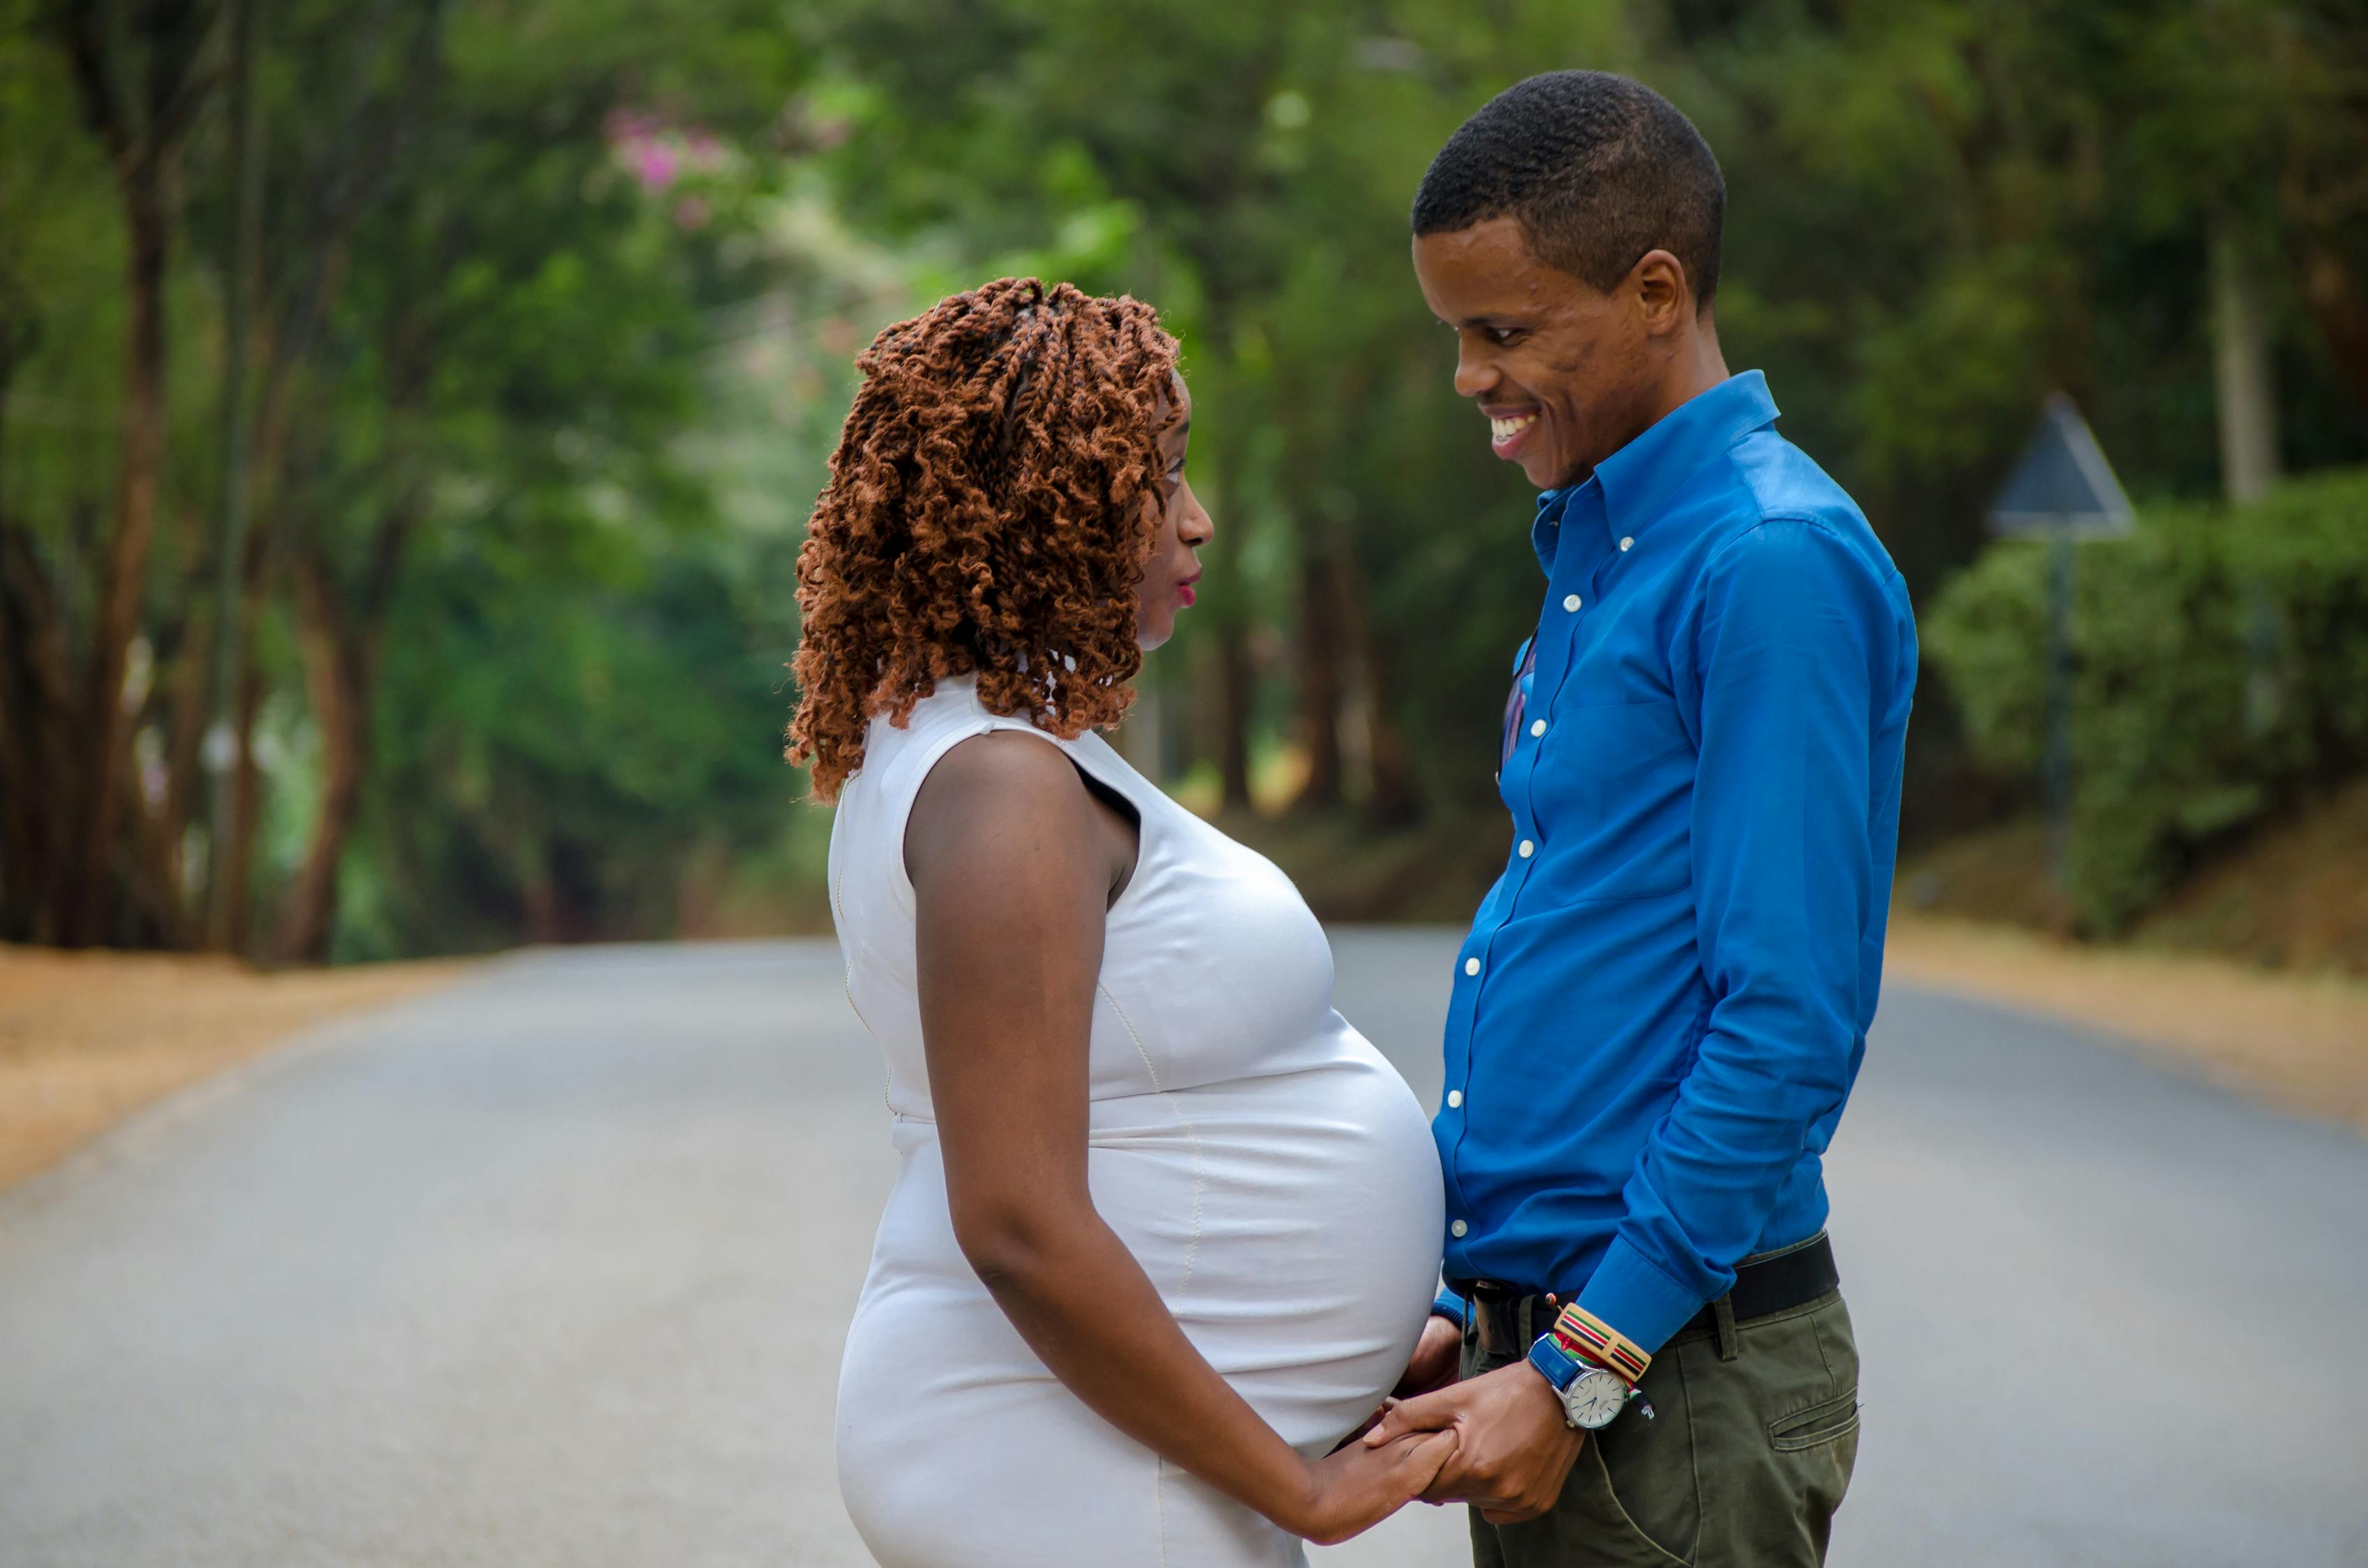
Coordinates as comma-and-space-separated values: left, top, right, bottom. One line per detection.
1433, 372, 1916, 1350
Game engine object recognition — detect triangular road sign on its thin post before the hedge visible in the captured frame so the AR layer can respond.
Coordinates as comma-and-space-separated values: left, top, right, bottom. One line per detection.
1989, 393, 2136, 891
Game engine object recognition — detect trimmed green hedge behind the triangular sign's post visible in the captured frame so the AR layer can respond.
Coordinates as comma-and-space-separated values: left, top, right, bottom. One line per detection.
1925, 471, 2368, 933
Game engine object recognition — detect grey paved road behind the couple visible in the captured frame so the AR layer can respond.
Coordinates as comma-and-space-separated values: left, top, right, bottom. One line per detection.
0, 931, 2368, 1568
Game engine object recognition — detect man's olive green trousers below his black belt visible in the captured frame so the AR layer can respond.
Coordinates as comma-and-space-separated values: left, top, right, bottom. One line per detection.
1463, 1291, 1859, 1568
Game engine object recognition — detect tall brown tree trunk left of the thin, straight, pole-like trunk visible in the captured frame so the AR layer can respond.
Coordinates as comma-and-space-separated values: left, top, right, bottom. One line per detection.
59, 175, 168, 948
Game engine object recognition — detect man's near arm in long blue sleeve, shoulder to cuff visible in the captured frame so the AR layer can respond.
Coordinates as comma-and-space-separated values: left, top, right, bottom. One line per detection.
1580, 518, 1897, 1350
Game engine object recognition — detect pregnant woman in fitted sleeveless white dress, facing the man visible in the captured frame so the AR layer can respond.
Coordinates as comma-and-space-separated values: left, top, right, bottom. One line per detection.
791, 279, 1456, 1568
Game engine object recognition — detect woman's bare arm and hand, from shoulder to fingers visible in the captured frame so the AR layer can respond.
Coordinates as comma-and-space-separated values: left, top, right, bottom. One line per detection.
905, 732, 1454, 1539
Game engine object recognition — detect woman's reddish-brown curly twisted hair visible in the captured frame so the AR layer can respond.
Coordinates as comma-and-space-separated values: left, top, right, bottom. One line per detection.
788, 277, 1177, 801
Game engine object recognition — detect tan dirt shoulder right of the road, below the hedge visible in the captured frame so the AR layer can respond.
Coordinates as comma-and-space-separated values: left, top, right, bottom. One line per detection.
1883, 909, 2368, 1132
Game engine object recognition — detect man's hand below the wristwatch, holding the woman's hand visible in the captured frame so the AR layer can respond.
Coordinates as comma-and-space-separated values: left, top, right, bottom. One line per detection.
1364, 1362, 1584, 1525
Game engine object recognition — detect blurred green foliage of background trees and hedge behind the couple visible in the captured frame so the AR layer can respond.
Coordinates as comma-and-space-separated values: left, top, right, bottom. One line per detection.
0, 0, 2368, 955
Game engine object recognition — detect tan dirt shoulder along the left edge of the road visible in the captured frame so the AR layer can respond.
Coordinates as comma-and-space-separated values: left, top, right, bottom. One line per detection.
0, 945, 471, 1187
